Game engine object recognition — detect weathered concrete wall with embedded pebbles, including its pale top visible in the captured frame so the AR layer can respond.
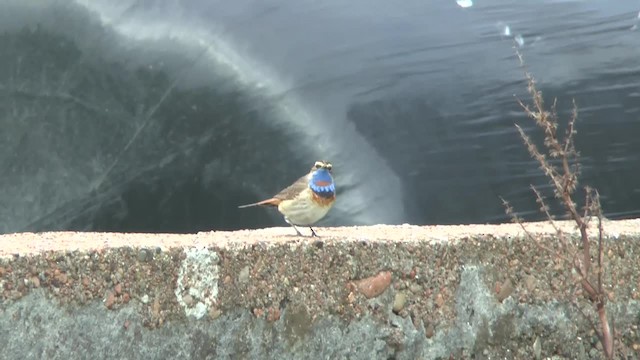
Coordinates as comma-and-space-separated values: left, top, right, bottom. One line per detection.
0, 220, 640, 359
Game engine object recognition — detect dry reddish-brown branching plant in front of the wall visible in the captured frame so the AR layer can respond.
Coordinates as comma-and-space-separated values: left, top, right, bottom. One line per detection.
510, 50, 615, 359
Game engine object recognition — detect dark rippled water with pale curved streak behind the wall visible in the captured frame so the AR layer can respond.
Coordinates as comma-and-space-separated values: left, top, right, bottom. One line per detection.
0, 0, 640, 232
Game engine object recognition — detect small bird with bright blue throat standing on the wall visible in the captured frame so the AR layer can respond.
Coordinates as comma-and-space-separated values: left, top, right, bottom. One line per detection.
239, 161, 336, 236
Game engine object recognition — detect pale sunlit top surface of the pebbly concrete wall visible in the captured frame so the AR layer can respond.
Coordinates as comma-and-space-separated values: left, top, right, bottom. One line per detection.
0, 219, 640, 257
